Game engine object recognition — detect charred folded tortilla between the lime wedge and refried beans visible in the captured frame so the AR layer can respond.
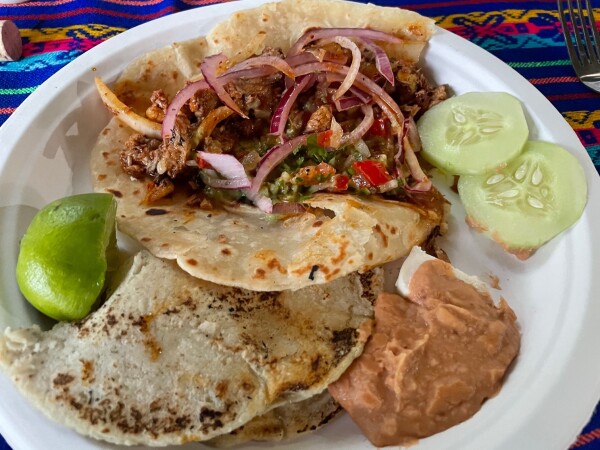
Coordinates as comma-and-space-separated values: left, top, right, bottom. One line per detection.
0, 251, 382, 446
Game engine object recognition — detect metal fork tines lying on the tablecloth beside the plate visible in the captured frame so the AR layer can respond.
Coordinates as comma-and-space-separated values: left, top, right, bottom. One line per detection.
558, 0, 600, 92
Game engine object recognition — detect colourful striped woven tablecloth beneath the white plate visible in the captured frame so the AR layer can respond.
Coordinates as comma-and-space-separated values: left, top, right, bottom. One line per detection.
0, 0, 600, 450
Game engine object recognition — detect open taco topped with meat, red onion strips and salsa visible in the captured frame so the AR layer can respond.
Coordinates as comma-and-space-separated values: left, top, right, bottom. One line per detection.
92, 0, 446, 290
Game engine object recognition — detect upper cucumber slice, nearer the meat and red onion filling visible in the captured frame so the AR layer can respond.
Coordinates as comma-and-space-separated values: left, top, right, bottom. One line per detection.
417, 92, 529, 175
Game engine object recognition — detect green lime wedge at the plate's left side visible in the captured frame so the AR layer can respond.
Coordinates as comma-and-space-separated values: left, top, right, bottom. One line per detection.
17, 194, 116, 320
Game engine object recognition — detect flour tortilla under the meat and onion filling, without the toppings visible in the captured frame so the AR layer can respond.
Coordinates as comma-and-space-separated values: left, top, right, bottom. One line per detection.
91, 0, 444, 291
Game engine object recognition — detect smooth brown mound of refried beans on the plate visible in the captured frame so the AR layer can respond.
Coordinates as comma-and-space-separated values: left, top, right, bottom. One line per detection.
329, 260, 520, 446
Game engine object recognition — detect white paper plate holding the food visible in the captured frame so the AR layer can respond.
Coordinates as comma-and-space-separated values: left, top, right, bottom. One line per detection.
0, 0, 600, 450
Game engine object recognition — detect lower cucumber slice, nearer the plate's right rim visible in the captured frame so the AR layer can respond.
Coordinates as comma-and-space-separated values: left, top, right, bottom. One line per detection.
458, 141, 587, 259
